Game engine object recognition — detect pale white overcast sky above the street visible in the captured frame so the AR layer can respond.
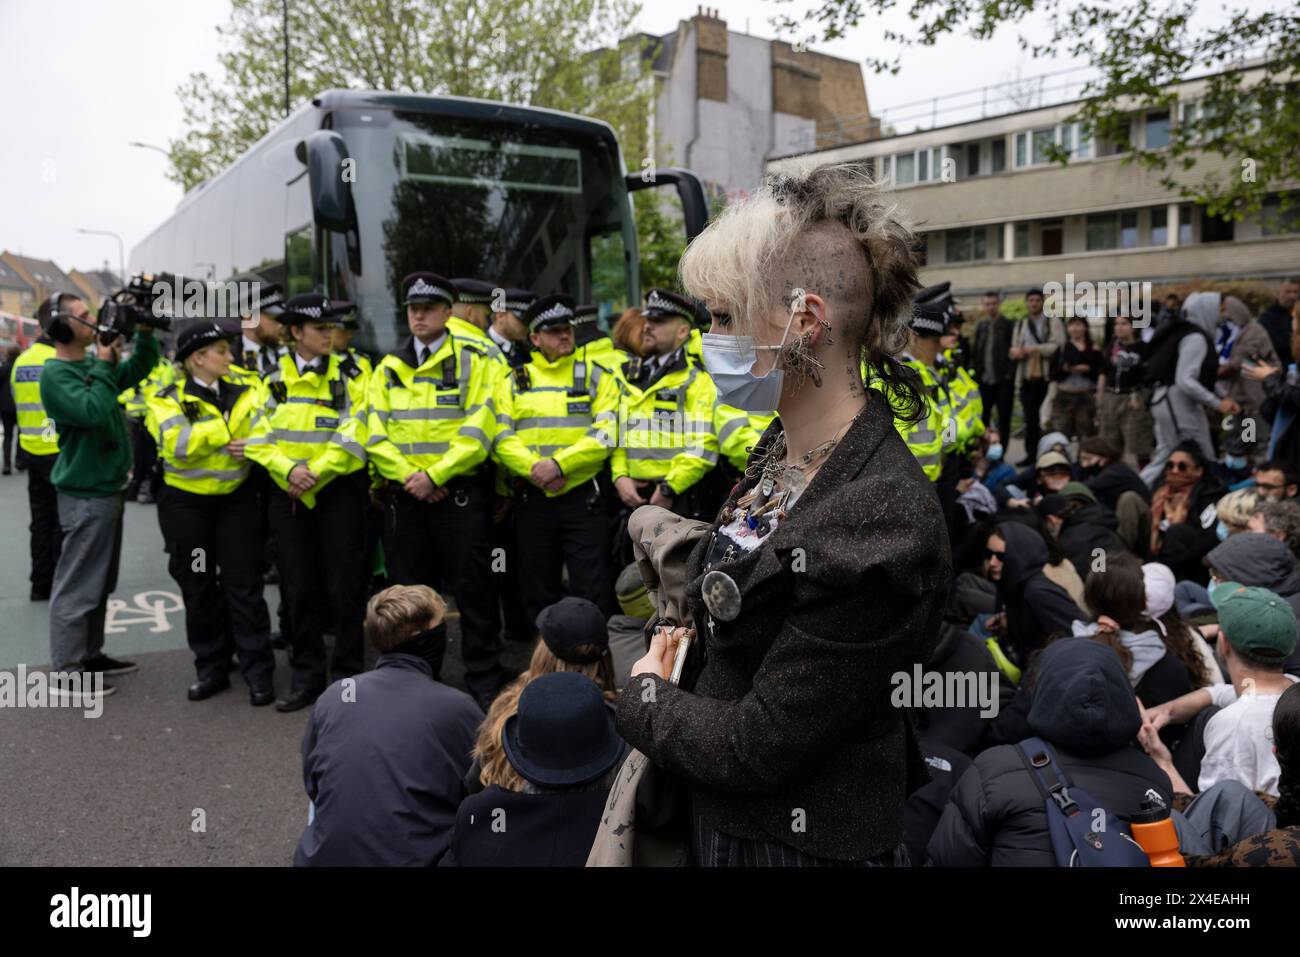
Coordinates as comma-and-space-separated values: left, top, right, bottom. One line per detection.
0, 0, 1284, 276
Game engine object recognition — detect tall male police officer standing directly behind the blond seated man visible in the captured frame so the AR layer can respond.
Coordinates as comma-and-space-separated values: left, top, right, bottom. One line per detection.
367, 272, 506, 710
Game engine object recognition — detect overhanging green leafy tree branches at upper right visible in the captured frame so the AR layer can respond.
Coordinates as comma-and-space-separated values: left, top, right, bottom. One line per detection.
772, 0, 1300, 218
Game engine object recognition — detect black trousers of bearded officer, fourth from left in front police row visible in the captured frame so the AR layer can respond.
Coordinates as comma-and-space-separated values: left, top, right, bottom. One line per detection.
512, 482, 615, 622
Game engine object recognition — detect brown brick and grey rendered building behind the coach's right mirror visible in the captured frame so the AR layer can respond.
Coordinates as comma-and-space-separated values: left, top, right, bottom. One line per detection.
644, 9, 879, 202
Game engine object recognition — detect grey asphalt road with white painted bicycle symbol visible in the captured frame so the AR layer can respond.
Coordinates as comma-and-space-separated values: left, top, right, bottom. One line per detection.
0, 472, 529, 866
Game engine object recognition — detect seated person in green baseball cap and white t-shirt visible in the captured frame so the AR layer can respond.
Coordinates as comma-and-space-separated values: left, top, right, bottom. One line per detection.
1148, 581, 1296, 794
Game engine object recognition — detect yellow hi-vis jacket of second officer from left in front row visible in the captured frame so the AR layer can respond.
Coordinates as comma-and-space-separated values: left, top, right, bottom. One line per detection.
244, 355, 368, 508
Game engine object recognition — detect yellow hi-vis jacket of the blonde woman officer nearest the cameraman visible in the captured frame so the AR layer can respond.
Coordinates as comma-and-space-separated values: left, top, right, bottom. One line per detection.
144, 374, 261, 495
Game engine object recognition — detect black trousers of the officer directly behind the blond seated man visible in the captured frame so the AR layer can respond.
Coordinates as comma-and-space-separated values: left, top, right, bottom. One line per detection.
384, 476, 508, 694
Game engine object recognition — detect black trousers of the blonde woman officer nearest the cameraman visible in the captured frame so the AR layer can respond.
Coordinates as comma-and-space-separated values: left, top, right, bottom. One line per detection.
159, 481, 276, 688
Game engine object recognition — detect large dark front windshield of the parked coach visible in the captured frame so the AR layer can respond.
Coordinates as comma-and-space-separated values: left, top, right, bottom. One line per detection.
327, 109, 638, 348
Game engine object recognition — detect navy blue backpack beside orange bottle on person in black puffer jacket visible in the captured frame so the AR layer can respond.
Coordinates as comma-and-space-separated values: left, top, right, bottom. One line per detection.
1015, 737, 1151, 867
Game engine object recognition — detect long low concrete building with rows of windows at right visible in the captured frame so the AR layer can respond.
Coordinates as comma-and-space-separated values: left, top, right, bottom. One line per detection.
768, 62, 1300, 295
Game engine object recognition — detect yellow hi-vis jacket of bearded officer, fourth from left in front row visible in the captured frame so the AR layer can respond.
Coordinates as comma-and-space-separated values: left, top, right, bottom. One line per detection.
493, 350, 620, 498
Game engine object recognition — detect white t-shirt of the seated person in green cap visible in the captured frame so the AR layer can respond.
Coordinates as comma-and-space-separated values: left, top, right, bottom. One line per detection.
1196, 675, 1297, 794
